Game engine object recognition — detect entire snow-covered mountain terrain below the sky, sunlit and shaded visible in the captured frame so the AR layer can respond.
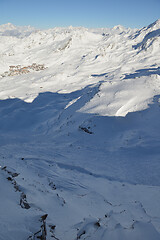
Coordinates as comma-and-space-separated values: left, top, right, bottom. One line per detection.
0, 20, 160, 240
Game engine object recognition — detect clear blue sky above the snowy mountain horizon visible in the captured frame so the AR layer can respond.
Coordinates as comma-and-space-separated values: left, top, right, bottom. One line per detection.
0, 0, 160, 28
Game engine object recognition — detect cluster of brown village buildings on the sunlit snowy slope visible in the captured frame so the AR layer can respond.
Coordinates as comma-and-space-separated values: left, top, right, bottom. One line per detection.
1, 63, 45, 77
